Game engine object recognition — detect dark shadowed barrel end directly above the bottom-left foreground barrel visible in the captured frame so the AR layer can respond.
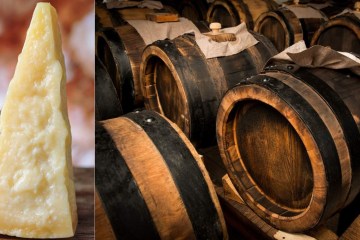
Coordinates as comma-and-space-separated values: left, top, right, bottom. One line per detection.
95, 57, 123, 121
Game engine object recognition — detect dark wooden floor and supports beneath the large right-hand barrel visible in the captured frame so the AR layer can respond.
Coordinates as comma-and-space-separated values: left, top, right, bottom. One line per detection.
198, 146, 360, 240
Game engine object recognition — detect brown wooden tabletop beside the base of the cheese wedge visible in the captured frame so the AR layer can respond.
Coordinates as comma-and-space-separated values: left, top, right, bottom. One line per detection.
0, 168, 94, 240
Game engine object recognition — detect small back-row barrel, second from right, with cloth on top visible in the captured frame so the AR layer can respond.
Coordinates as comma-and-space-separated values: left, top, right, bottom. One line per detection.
254, 5, 327, 51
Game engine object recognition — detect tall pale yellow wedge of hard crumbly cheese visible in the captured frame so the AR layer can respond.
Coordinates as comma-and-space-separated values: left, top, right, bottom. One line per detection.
0, 3, 77, 238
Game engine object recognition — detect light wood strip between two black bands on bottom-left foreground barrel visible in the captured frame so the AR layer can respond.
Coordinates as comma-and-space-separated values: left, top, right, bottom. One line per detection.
106, 118, 195, 239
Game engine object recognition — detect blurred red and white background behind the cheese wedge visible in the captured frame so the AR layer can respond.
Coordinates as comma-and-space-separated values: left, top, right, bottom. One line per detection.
0, 0, 95, 167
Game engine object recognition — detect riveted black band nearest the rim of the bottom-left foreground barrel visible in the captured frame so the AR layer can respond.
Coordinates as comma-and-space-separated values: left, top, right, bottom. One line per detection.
126, 111, 223, 239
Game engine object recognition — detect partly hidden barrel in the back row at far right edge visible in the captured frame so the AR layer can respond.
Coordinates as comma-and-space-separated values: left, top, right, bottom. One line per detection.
311, 13, 360, 54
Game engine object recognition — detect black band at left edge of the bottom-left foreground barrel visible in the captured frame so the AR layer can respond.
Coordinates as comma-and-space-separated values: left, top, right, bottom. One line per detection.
95, 123, 160, 240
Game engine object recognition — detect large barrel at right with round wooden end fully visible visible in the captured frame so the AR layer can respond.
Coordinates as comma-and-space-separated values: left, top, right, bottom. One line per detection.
216, 64, 360, 232
